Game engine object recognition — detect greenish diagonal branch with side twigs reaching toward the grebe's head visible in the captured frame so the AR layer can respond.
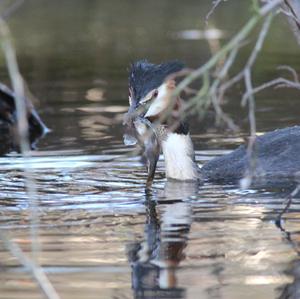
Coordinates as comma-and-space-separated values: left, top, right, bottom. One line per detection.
175, 0, 283, 123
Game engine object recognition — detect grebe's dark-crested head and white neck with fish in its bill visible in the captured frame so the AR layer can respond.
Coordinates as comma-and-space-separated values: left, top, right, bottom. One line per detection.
124, 60, 197, 184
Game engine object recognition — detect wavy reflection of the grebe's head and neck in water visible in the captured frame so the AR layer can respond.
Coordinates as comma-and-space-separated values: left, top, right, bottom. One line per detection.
127, 181, 198, 299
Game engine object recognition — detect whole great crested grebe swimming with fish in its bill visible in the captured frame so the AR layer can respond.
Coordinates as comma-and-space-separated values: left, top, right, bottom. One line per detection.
124, 60, 300, 183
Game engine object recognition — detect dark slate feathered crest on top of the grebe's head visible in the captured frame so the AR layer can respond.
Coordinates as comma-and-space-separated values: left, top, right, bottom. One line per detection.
129, 60, 184, 103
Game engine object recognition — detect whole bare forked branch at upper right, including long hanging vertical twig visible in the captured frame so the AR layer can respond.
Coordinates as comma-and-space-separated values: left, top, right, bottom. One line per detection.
170, 0, 300, 188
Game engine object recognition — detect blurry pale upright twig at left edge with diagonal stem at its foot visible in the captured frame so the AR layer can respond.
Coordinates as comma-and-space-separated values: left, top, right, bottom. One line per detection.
0, 7, 59, 299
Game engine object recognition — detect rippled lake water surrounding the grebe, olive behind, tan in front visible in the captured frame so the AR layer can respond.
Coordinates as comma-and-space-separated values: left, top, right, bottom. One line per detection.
0, 0, 300, 299
